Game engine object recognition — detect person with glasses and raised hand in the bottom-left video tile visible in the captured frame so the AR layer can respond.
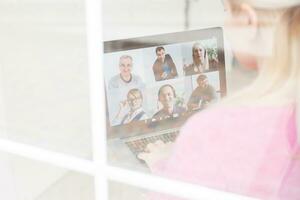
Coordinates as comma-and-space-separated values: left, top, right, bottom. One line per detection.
115, 88, 147, 124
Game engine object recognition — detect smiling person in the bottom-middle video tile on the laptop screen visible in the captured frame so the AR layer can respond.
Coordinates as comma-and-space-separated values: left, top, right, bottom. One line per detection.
152, 84, 186, 120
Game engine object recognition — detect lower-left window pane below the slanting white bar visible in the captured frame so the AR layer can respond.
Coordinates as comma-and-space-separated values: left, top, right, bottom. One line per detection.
0, 153, 94, 200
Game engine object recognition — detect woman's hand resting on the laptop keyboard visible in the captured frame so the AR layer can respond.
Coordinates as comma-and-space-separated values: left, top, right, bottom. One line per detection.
138, 140, 173, 170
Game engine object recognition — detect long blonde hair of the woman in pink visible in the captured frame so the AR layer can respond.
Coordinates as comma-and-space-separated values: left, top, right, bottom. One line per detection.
223, 6, 300, 106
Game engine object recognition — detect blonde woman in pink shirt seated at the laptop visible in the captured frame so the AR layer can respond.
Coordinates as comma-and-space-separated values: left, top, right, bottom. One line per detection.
139, 0, 300, 200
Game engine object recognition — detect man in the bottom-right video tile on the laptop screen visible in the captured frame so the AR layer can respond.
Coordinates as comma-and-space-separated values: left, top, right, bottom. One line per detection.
187, 74, 217, 110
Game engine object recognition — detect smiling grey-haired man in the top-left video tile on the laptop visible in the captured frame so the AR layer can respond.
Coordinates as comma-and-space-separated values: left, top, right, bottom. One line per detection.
108, 55, 144, 89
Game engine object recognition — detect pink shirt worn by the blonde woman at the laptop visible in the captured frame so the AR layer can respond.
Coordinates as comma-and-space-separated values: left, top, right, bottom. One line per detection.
153, 105, 300, 200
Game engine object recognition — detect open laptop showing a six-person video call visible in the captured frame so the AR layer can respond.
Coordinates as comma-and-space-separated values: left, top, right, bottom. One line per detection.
104, 27, 226, 170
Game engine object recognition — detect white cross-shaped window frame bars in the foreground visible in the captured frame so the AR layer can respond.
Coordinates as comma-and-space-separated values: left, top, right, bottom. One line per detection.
0, 0, 253, 200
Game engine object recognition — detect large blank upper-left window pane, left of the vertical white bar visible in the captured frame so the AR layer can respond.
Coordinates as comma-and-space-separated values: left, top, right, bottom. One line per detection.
0, 0, 91, 158
